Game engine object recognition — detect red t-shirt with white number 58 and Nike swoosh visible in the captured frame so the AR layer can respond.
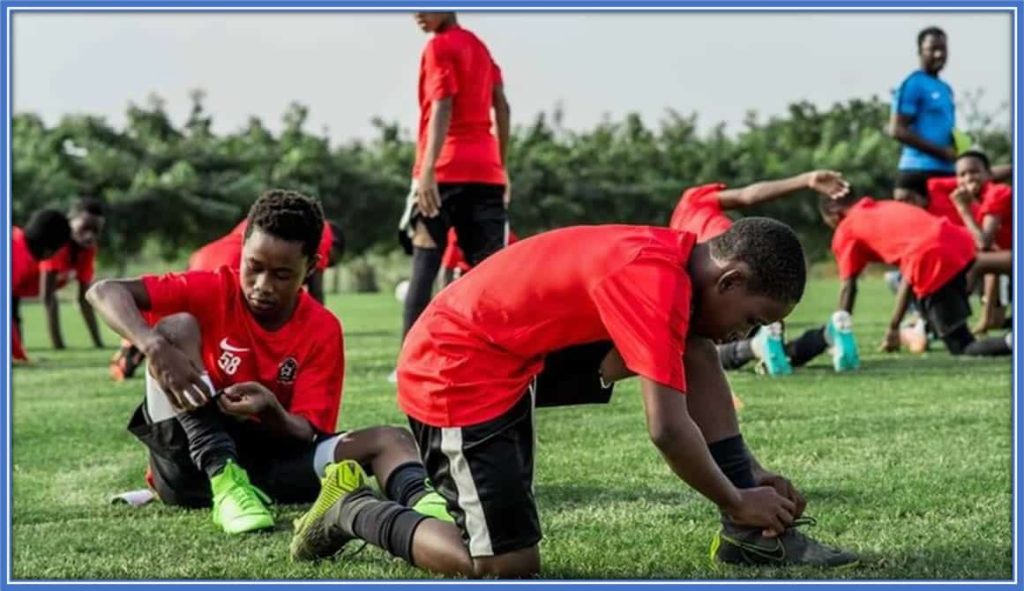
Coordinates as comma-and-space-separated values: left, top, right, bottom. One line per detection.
142, 267, 345, 433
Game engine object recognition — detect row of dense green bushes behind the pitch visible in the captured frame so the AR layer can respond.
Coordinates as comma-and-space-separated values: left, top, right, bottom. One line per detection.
12, 90, 1010, 263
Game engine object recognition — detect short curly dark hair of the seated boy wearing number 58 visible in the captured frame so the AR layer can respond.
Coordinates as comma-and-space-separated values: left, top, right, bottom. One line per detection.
245, 189, 324, 258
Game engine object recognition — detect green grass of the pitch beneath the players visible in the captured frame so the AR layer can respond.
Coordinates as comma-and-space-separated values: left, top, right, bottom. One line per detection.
12, 280, 1012, 579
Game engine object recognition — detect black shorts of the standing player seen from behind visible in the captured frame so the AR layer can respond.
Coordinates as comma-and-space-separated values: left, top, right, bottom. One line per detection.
410, 182, 508, 266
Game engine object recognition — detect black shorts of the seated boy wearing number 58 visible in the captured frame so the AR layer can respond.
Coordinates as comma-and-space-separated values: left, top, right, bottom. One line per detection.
128, 403, 333, 507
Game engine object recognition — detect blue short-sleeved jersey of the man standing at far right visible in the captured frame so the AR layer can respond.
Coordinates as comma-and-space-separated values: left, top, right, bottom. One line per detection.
893, 70, 956, 173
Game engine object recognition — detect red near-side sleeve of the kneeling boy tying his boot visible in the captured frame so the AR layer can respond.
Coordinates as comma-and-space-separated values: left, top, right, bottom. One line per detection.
591, 251, 690, 392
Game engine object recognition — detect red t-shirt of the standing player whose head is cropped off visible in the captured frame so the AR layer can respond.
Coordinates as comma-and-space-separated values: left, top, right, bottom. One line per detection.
413, 26, 505, 184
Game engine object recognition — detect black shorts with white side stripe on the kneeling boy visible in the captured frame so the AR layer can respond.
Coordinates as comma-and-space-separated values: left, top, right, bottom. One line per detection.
409, 342, 612, 557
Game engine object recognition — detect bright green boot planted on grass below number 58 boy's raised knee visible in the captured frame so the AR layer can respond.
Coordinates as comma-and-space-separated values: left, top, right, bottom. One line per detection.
210, 461, 273, 534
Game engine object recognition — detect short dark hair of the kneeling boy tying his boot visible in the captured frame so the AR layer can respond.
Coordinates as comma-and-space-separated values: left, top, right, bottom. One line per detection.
709, 217, 807, 304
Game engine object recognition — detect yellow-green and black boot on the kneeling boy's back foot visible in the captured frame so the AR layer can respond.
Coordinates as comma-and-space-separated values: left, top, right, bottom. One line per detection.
289, 460, 370, 561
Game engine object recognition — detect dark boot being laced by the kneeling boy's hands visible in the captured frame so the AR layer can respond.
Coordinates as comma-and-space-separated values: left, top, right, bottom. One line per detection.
711, 517, 859, 567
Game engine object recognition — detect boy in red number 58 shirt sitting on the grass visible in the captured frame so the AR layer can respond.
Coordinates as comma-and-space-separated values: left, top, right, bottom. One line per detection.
88, 191, 443, 534
